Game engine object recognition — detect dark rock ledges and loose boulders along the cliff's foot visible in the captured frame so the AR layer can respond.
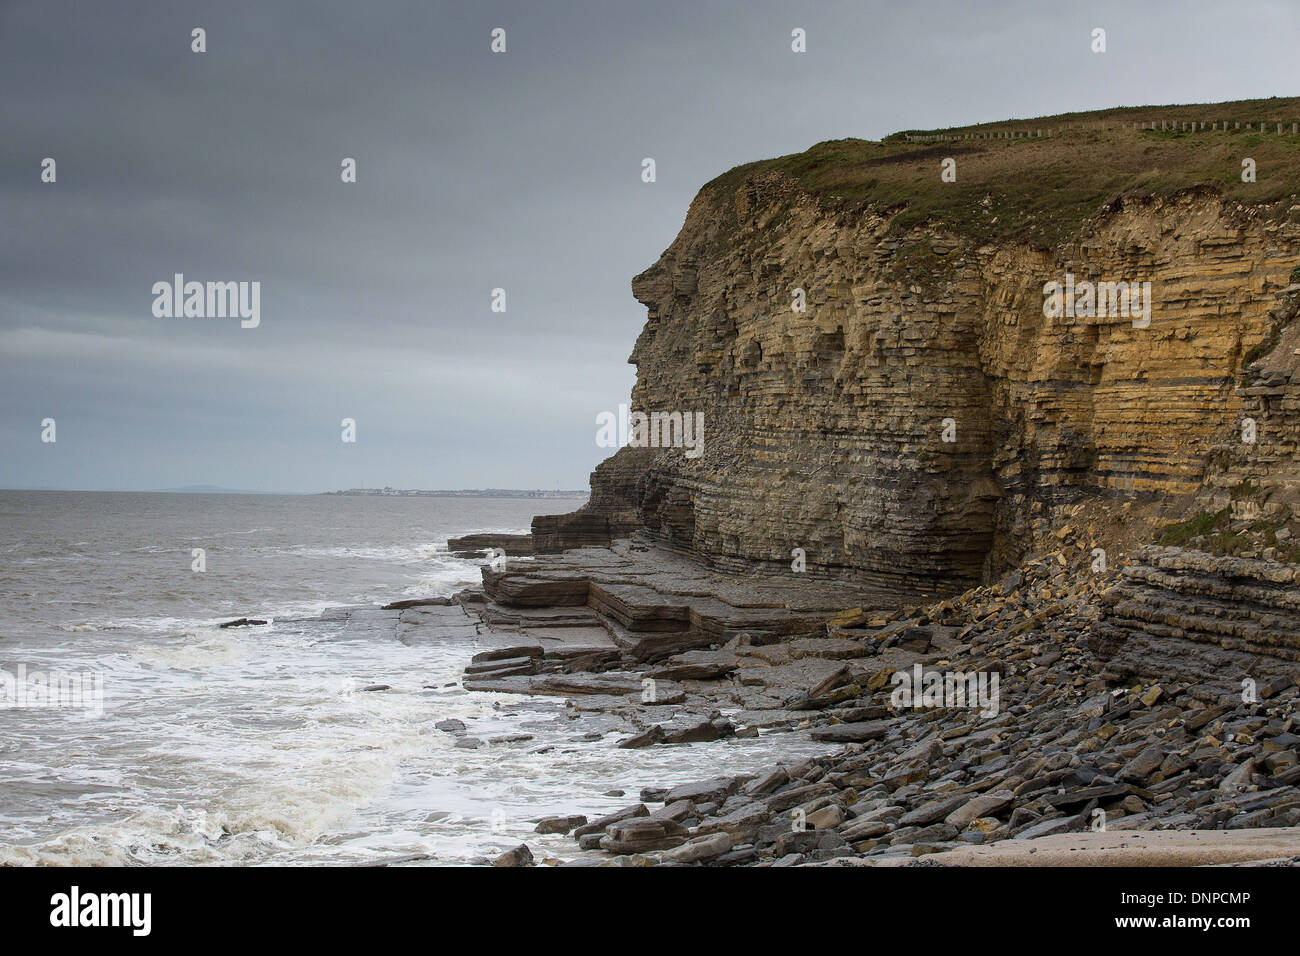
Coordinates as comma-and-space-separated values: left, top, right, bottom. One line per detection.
402, 535, 1300, 866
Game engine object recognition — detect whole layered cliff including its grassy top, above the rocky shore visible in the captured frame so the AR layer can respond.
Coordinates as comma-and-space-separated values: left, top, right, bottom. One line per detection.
534, 99, 1300, 591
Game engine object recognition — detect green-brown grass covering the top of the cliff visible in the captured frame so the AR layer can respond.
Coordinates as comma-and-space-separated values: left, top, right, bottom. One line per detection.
705, 98, 1300, 248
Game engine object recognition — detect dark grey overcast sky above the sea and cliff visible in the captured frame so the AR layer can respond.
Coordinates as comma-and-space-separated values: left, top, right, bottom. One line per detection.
0, 0, 1300, 492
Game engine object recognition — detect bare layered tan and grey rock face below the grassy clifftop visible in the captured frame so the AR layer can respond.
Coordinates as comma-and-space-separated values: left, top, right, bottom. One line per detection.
537, 159, 1300, 588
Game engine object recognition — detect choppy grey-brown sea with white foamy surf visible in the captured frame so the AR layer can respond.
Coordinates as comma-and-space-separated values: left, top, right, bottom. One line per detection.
0, 492, 818, 865
